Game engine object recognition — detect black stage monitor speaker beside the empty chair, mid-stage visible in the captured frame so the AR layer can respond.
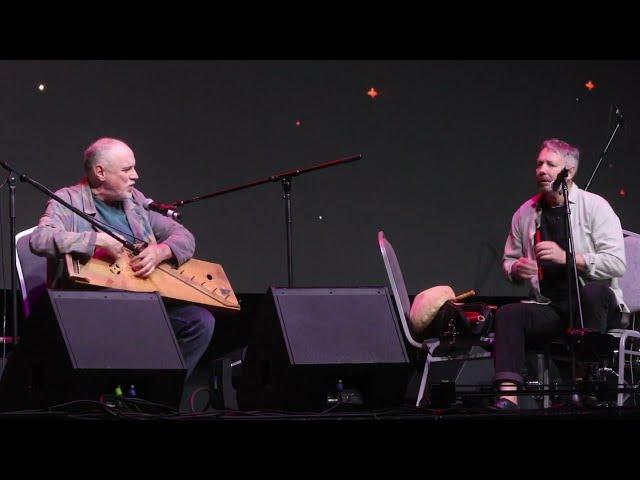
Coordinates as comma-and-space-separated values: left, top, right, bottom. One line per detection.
237, 287, 411, 411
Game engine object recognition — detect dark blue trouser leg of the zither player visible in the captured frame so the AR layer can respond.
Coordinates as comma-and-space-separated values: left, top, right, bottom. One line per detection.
165, 304, 215, 378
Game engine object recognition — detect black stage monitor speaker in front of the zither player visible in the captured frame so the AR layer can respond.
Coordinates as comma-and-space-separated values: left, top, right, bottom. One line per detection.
0, 290, 186, 410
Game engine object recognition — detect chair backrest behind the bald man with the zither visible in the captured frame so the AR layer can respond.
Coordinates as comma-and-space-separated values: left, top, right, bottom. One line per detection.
16, 227, 47, 318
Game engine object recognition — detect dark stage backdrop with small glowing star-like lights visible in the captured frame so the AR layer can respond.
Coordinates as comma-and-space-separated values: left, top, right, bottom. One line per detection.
0, 60, 640, 296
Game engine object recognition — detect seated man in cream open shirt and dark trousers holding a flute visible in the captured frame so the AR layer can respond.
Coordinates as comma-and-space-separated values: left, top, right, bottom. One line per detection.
494, 139, 628, 409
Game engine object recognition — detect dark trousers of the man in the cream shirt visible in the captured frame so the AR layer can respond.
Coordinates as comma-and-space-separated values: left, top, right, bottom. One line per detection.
493, 283, 620, 385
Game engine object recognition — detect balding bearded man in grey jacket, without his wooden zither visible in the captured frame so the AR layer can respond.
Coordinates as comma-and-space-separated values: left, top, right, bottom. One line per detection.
30, 138, 215, 378
